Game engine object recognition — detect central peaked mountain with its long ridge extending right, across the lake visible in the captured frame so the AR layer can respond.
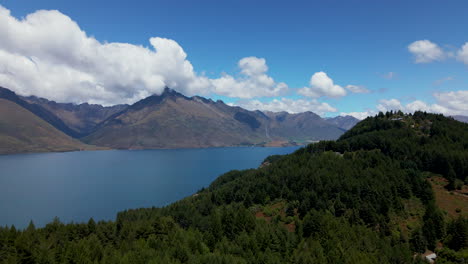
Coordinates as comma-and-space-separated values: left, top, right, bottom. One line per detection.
83, 89, 344, 149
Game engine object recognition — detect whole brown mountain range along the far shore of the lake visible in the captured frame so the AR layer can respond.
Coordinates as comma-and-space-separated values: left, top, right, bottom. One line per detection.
0, 87, 359, 153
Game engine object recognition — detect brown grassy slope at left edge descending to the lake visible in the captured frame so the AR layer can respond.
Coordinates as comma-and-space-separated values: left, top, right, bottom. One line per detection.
0, 99, 95, 154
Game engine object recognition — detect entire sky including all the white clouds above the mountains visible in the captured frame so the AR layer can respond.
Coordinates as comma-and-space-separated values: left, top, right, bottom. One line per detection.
0, 0, 468, 119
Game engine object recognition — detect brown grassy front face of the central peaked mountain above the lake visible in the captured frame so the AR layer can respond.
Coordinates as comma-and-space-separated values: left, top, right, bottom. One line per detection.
85, 97, 264, 149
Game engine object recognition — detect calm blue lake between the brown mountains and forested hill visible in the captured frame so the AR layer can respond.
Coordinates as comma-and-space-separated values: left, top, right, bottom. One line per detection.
0, 147, 298, 228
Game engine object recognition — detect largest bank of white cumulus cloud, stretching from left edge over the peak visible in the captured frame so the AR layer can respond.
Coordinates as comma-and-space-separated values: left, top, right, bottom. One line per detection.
0, 6, 288, 105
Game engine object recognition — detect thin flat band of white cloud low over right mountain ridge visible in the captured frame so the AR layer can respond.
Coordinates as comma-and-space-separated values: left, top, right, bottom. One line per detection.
231, 98, 337, 115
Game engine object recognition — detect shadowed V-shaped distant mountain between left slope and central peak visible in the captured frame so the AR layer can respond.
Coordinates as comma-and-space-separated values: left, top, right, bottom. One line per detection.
22, 96, 128, 137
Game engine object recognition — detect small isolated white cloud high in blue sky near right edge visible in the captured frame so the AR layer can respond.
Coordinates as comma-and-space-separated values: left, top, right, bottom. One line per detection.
408, 40, 446, 63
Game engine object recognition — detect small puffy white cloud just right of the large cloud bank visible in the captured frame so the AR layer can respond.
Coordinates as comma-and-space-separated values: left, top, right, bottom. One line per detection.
298, 72, 346, 98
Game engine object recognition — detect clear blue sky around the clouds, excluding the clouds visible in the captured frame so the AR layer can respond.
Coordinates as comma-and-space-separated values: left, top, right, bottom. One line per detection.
0, 0, 468, 116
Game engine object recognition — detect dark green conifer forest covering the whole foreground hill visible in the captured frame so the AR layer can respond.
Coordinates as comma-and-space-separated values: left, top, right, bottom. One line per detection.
0, 112, 468, 264
